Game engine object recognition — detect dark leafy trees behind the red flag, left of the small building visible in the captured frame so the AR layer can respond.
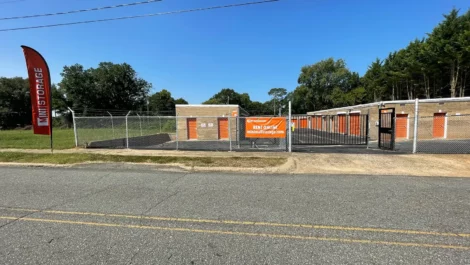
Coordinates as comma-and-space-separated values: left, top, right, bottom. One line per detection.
0, 62, 188, 128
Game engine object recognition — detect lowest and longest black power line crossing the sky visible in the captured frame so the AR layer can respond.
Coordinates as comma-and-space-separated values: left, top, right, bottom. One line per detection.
0, 0, 280, 32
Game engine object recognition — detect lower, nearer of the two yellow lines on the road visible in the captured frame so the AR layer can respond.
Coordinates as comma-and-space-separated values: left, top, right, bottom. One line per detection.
0, 216, 470, 250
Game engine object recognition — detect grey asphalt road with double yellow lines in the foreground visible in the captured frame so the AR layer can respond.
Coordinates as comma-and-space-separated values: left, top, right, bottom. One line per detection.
0, 165, 470, 264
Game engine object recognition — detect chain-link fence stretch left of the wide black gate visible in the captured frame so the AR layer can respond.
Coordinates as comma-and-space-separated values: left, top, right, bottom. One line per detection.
75, 114, 287, 151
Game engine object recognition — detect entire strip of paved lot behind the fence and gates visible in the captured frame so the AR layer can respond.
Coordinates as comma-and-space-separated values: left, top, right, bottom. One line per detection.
91, 129, 470, 154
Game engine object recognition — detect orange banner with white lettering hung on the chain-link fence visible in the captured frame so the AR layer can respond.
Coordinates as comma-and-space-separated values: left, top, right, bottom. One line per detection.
245, 117, 286, 138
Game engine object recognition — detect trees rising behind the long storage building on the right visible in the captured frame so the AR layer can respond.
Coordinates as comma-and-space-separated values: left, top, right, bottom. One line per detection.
198, 9, 470, 112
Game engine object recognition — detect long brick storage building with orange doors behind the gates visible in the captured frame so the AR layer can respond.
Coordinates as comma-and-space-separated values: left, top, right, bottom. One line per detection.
299, 97, 470, 140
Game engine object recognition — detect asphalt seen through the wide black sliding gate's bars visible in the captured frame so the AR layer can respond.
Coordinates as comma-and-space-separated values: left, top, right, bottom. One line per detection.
292, 129, 367, 145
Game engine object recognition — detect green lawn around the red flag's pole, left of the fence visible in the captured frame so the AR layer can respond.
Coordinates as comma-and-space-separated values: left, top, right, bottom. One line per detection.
0, 129, 75, 149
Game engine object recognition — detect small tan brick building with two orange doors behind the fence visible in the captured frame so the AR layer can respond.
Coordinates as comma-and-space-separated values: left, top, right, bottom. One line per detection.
176, 105, 240, 141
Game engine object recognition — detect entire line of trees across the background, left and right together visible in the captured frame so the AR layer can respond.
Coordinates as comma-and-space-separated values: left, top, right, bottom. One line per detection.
0, 9, 470, 128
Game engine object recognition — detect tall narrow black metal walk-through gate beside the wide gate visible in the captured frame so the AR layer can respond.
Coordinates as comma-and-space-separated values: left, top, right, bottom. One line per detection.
379, 108, 395, 150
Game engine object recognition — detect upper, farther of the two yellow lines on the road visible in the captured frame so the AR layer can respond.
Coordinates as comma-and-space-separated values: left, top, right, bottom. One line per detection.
0, 207, 470, 237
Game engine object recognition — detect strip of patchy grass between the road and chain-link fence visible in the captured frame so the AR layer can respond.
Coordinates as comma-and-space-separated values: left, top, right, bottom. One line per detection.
0, 152, 287, 168
